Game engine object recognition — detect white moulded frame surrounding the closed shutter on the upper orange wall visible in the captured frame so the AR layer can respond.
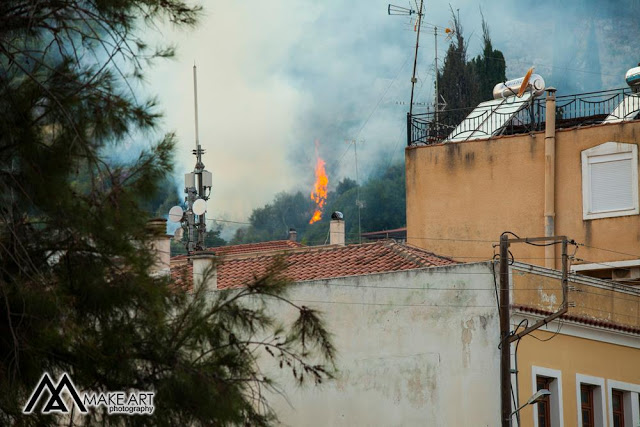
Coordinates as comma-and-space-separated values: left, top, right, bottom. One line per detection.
581, 142, 640, 220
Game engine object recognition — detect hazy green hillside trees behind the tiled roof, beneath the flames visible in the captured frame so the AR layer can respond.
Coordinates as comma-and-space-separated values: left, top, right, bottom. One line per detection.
232, 164, 406, 245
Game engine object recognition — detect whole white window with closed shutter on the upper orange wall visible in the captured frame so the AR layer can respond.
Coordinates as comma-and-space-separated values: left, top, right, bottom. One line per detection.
582, 142, 640, 219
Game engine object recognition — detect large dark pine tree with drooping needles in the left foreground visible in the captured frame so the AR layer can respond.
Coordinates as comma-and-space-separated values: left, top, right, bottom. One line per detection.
0, 0, 334, 426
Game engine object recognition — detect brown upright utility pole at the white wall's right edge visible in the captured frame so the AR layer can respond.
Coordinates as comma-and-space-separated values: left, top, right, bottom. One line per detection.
500, 234, 511, 427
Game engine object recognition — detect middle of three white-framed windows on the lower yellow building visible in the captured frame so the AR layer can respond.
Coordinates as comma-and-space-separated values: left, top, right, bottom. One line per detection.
576, 374, 607, 427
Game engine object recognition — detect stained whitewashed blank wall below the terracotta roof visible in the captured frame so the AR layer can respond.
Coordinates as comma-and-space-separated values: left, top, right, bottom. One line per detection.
263, 263, 500, 426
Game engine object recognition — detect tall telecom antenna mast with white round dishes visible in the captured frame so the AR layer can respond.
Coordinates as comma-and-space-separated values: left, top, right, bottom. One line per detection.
169, 64, 213, 253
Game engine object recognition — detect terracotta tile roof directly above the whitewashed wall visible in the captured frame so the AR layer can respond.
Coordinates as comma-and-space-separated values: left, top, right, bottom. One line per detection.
171, 240, 456, 289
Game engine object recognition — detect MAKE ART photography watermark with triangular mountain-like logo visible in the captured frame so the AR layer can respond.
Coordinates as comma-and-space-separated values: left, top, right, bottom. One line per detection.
22, 372, 155, 415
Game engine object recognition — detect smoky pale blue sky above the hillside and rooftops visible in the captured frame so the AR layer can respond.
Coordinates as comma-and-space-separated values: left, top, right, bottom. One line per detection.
148, 0, 640, 231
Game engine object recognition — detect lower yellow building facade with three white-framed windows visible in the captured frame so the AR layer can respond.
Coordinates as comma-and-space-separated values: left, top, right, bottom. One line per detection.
510, 263, 640, 427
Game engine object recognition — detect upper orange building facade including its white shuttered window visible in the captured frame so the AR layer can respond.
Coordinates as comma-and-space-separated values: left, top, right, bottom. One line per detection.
406, 121, 640, 280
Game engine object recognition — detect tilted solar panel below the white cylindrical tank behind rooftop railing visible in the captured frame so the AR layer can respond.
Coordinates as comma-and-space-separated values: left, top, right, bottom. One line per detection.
445, 92, 531, 142
